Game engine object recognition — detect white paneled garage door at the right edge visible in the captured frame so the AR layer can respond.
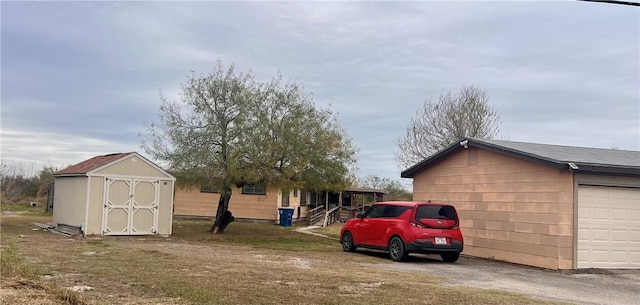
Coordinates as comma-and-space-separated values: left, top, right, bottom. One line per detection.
577, 185, 640, 268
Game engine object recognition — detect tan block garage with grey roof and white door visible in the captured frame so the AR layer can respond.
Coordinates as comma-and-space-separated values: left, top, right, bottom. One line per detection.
401, 138, 640, 269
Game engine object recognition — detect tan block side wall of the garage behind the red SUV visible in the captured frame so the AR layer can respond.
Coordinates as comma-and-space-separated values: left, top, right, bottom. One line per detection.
413, 148, 574, 269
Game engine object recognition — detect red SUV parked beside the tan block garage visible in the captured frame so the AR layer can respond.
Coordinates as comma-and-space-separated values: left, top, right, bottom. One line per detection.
340, 201, 464, 262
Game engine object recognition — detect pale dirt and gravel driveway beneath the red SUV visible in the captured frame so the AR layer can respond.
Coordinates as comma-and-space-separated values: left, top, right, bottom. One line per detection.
359, 251, 640, 305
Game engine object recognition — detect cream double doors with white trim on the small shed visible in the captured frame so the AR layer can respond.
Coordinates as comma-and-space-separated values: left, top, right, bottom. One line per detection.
102, 178, 160, 235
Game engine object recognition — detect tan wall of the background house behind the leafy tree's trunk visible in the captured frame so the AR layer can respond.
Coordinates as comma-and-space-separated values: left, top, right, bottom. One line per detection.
173, 187, 279, 220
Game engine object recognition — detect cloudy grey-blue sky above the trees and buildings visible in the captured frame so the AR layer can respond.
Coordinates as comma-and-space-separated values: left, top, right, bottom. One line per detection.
0, 1, 640, 180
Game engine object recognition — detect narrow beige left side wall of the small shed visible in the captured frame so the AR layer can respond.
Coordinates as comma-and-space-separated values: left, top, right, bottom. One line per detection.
53, 176, 87, 226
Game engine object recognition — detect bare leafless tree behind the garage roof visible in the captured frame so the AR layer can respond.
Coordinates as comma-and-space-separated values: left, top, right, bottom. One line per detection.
396, 86, 500, 168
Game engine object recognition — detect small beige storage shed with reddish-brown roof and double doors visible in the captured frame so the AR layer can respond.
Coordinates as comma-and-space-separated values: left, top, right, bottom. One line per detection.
53, 152, 175, 235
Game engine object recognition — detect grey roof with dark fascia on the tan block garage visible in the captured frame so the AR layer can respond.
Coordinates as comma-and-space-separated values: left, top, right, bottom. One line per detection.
401, 138, 640, 178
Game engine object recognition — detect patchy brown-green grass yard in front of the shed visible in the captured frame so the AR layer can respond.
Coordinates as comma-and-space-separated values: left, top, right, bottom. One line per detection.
2, 215, 568, 305
